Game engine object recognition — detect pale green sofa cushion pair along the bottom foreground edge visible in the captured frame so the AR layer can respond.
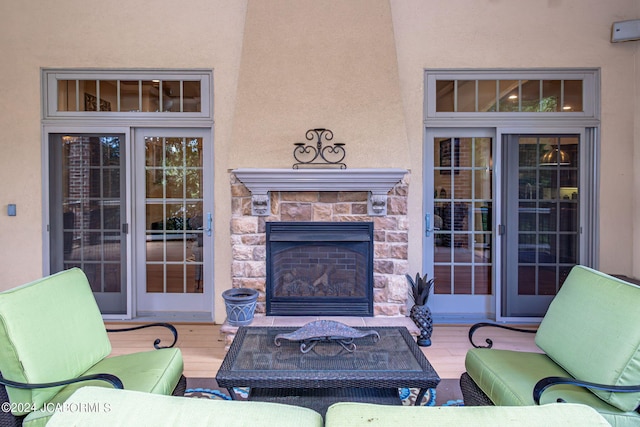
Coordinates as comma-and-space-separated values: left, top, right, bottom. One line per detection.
48, 387, 609, 427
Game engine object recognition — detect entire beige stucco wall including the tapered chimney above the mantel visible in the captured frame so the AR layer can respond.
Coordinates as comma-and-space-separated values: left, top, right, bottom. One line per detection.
0, 0, 640, 322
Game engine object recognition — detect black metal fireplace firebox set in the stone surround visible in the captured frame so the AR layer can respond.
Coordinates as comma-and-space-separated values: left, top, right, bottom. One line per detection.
266, 222, 373, 316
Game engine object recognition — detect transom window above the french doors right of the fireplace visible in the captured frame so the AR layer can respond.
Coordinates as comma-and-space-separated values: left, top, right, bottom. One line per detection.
425, 69, 599, 125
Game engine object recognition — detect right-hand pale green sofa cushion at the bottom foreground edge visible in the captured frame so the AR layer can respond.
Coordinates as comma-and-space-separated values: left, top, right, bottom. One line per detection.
325, 402, 610, 427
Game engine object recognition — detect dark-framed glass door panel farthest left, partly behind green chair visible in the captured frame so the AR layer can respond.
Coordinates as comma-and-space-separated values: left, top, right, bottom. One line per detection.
49, 134, 127, 314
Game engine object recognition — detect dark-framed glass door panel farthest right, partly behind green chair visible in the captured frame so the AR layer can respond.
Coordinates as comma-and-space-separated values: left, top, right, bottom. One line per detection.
503, 135, 580, 317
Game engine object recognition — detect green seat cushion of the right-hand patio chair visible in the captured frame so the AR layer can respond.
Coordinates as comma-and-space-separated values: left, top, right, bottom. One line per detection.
465, 348, 640, 427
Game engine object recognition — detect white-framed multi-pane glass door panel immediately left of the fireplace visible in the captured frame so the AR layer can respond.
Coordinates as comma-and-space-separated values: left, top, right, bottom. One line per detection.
137, 131, 212, 312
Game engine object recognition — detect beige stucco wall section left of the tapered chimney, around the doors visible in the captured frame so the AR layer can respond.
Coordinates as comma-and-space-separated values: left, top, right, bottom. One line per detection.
0, 0, 247, 311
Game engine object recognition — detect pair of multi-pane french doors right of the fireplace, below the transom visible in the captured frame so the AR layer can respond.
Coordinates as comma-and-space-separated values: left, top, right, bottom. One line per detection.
424, 128, 594, 319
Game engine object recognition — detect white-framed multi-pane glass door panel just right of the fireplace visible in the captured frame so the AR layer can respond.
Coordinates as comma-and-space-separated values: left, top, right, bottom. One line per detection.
425, 130, 494, 316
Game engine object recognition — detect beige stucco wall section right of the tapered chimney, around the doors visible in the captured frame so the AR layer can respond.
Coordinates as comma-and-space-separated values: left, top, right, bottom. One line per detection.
391, 0, 640, 276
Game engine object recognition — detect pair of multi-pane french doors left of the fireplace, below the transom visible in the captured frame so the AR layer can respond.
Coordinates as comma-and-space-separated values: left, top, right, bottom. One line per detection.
48, 128, 213, 319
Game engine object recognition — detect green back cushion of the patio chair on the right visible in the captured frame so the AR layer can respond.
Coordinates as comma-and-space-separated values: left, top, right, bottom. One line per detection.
536, 266, 640, 411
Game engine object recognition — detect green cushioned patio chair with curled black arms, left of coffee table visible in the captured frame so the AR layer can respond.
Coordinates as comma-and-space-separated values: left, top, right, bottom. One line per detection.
0, 268, 186, 426
